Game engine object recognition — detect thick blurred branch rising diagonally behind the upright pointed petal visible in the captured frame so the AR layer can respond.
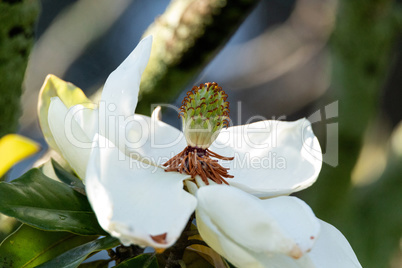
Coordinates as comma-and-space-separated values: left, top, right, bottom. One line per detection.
136, 0, 260, 114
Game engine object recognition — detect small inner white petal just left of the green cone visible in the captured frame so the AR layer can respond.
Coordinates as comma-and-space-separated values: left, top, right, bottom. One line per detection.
119, 107, 187, 165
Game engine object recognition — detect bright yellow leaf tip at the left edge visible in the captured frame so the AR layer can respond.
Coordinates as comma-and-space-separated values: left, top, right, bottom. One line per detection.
0, 134, 40, 177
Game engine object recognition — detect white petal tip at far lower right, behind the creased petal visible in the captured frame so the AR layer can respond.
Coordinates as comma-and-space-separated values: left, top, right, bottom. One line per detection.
306, 220, 361, 268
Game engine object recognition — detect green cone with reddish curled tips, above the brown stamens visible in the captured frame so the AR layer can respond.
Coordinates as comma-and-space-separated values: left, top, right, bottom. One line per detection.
179, 82, 230, 149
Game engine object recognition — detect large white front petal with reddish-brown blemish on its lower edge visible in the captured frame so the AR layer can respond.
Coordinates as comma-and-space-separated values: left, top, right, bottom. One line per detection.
85, 135, 197, 248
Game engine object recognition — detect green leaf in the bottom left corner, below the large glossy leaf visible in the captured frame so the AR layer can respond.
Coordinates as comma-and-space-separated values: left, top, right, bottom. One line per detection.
0, 224, 96, 268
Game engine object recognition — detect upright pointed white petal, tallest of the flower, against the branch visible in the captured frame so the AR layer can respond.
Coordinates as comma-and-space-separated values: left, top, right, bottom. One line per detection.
101, 36, 152, 117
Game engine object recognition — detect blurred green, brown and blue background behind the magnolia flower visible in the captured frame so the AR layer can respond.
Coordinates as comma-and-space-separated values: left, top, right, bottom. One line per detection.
0, 0, 402, 268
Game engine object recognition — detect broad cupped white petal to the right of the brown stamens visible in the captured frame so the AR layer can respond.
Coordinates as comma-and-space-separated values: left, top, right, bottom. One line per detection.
210, 119, 322, 197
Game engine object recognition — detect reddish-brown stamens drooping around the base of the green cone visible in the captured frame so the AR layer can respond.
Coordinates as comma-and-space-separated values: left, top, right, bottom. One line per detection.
163, 146, 234, 185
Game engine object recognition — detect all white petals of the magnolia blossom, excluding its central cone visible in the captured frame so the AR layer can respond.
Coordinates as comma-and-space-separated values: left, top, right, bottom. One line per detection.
43, 37, 360, 267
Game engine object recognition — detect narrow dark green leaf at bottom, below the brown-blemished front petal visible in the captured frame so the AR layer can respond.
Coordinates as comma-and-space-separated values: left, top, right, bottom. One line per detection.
38, 236, 120, 268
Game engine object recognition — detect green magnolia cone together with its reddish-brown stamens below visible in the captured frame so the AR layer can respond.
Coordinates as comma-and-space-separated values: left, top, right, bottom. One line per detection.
163, 83, 234, 185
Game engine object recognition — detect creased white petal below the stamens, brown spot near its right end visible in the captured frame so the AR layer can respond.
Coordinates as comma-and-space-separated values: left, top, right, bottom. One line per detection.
196, 185, 320, 267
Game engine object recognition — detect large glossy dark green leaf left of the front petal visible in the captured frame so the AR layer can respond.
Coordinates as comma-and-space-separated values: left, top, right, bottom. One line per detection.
0, 168, 105, 235
